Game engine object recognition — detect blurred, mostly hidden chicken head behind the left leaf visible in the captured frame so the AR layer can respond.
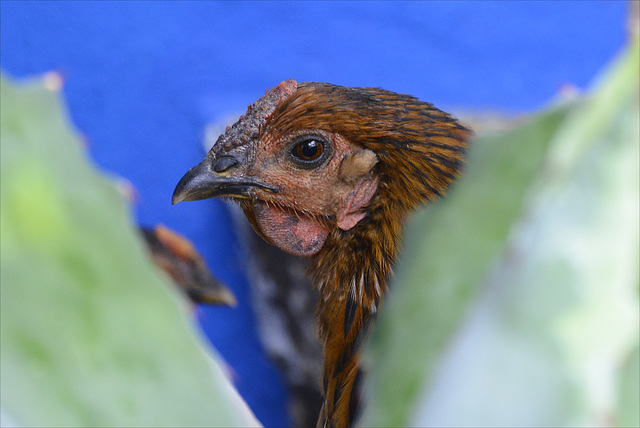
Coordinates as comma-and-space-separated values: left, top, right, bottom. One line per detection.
140, 225, 236, 306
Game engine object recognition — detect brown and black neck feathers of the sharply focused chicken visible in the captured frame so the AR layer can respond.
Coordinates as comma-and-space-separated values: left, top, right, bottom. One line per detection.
310, 194, 402, 427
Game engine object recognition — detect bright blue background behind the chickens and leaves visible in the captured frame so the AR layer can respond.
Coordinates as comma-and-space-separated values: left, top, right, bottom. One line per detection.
0, 1, 629, 426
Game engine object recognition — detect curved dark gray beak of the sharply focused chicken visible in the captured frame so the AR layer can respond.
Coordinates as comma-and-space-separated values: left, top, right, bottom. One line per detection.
171, 157, 280, 205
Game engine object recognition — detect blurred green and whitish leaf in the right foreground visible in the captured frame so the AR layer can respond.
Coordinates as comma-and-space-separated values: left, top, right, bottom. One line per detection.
362, 38, 640, 426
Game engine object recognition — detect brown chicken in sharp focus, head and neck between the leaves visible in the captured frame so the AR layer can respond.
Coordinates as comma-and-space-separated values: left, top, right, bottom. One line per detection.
173, 79, 470, 427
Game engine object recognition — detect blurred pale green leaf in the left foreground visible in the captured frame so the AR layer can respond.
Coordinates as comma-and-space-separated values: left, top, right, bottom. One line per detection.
1, 74, 257, 426
